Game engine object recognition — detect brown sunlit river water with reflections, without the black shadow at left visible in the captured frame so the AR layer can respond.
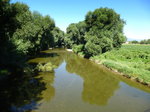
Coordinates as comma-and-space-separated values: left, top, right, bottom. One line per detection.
29, 49, 150, 112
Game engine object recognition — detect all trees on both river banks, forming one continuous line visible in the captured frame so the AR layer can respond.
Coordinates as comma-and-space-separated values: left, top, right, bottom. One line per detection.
0, 0, 126, 74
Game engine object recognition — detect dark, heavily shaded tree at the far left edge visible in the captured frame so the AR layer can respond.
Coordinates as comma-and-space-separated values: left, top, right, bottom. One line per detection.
0, 0, 20, 65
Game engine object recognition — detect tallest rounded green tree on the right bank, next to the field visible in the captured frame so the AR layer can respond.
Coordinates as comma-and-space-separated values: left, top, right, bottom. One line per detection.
85, 8, 126, 57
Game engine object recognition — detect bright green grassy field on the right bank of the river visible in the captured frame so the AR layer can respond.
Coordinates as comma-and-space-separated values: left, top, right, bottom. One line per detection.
91, 45, 150, 83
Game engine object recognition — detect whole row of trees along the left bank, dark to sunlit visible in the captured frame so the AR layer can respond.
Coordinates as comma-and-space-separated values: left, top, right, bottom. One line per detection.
0, 0, 64, 72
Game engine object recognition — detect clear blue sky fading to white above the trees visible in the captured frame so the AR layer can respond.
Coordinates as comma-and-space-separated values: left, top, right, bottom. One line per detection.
11, 0, 150, 41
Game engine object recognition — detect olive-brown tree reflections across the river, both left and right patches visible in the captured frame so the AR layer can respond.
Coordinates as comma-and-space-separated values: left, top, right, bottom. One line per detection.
30, 50, 119, 105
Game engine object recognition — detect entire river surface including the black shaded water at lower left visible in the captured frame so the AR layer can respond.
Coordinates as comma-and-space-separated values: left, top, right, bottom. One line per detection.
4, 49, 150, 112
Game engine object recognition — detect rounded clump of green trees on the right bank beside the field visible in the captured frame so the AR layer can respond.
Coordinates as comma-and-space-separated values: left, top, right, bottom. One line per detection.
64, 8, 126, 58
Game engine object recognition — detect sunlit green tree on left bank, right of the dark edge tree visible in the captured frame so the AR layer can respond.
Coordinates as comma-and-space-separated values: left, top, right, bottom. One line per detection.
12, 7, 55, 55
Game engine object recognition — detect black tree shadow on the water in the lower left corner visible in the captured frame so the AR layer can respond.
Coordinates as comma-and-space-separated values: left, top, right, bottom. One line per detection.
0, 72, 46, 112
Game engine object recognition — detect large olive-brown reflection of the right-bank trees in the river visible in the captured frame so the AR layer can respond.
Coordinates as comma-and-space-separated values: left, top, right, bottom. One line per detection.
66, 54, 119, 105
